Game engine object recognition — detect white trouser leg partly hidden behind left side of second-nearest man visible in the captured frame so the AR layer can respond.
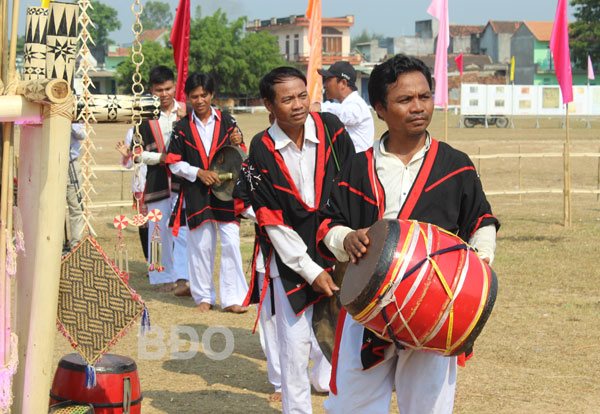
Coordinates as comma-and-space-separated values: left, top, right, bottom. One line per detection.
256, 272, 281, 392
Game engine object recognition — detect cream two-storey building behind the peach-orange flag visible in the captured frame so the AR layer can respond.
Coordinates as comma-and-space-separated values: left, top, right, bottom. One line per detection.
246, 15, 360, 67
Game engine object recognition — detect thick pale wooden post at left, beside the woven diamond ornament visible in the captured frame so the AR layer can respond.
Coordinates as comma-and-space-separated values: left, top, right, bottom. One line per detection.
13, 101, 73, 414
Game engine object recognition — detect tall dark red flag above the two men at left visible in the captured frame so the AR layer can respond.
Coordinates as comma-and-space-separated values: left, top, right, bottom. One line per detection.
171, 0, 190, 102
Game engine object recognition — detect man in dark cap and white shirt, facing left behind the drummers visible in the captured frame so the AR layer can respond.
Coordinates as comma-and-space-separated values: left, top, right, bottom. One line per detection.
310, 61, 375, 152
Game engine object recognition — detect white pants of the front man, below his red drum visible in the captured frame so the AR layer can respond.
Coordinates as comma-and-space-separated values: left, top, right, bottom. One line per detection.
324, 315, 456, 414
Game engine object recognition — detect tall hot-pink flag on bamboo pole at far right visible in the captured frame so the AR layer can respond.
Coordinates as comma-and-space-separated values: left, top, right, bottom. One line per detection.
550, 0, 573, 104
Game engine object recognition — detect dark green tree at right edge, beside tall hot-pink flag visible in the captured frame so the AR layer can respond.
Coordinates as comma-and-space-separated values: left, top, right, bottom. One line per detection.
569, 0, 600, 68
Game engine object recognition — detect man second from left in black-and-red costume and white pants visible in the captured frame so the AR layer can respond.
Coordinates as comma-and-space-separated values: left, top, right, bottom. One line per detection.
167, 72, 248, 313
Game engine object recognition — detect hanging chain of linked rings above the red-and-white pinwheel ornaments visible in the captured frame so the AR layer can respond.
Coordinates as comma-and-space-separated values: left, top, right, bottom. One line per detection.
131, 0, 144, 214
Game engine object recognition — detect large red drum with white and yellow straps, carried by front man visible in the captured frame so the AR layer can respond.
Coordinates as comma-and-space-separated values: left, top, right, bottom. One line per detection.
341, 220, 498, 356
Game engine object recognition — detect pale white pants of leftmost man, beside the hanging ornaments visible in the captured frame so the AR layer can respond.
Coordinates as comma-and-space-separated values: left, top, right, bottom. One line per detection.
146, 198, 177, 285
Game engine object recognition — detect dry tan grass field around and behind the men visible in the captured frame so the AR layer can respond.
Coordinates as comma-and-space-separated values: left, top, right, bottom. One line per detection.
54, 113, 600, 414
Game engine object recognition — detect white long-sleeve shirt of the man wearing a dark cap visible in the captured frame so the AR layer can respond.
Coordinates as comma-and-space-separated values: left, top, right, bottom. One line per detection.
321, 91, 375, 152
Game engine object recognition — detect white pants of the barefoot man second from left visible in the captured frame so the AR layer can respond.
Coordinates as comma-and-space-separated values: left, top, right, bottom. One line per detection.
187, 221, 248, 308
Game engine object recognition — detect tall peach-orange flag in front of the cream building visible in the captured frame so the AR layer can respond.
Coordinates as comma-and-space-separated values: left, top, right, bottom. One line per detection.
306, 0, 323, 102
